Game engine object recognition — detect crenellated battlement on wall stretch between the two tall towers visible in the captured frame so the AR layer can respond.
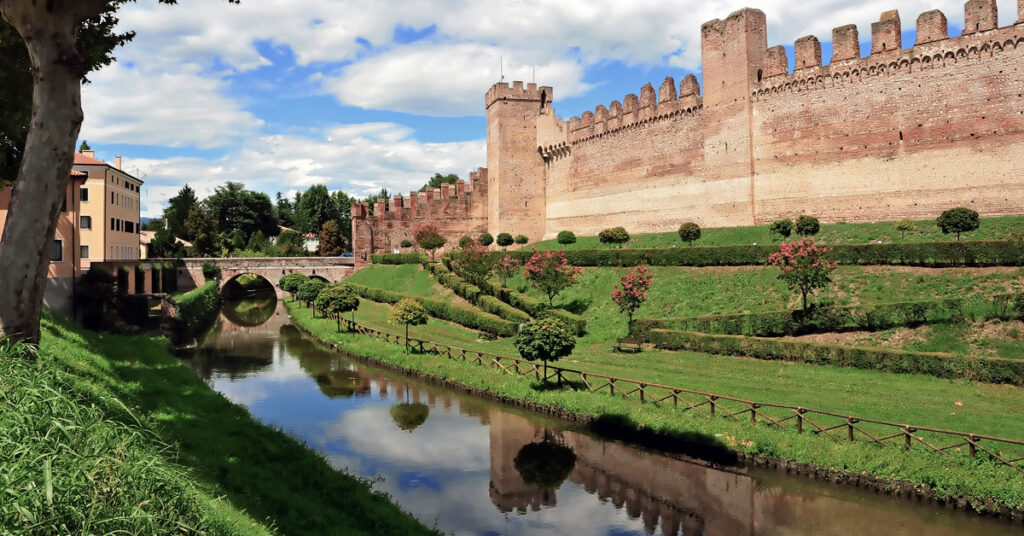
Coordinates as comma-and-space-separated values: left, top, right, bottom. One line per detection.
567, 75, 701, 145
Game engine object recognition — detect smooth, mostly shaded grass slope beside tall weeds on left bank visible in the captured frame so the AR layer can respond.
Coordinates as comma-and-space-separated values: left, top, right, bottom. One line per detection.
33, 311, 435, 535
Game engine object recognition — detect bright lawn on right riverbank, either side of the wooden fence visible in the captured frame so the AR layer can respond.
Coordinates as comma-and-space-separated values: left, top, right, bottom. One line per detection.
289, 303, 1024, 507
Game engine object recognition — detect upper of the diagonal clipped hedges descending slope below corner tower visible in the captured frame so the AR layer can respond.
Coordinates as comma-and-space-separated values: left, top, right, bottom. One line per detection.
436, 257, 587, 336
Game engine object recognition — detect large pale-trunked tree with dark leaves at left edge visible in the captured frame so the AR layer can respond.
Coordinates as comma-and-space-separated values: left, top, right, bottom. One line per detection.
0, 0, 238, 341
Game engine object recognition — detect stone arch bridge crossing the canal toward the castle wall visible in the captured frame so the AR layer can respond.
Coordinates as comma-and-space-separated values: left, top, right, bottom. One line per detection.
92, 257, 356, 298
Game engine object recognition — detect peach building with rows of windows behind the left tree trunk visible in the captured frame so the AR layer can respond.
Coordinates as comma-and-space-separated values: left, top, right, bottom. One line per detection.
0, 151, 142, 315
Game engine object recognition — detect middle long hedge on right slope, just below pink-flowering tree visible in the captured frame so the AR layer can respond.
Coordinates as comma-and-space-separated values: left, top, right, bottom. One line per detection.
631, 294, 1024, 339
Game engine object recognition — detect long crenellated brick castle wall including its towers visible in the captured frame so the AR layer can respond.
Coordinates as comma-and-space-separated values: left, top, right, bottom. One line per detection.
353, 0, 1024, 256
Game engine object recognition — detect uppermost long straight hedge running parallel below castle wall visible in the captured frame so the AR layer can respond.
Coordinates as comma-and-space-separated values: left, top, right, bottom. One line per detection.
497, 240, 1024, 267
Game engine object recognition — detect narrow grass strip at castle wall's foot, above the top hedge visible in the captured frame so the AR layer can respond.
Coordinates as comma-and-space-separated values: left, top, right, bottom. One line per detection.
535, 216, 1024, 249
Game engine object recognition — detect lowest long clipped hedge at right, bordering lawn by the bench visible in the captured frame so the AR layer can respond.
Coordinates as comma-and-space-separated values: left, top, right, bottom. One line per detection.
649, 329, 1024, 385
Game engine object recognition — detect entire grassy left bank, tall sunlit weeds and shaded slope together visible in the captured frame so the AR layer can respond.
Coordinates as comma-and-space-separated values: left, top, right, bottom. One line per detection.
0, 309, 431, 535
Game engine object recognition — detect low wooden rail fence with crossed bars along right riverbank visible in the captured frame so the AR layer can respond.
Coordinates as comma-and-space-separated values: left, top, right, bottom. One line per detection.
321, 311, 1024, 471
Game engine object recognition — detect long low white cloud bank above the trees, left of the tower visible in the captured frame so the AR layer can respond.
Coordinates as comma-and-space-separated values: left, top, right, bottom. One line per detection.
125, 123, 485, 216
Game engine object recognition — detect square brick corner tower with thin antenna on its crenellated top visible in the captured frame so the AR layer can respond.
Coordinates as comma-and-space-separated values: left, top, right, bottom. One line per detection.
484, 82, 552, 241
